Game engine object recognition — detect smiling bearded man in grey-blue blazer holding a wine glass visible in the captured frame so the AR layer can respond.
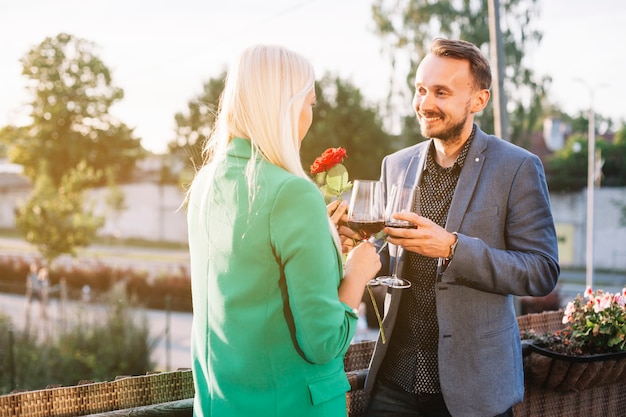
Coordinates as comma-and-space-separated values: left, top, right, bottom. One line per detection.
366, 39, 559, 417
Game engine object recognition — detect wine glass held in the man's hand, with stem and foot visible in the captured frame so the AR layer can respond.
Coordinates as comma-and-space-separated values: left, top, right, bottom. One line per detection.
372, 184, 420, 288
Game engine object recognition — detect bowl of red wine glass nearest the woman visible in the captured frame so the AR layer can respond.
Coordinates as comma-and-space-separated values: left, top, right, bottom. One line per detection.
348, 180, 385, 240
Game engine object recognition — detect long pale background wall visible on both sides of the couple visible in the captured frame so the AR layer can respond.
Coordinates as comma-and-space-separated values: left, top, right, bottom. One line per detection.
0, 179, 626, 271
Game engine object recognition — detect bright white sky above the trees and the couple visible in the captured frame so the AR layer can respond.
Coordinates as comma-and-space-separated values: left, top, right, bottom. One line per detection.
0, 0, 626, 152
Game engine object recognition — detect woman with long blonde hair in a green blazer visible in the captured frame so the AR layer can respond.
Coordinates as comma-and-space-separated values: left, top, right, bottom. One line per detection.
188, 46, 380, 417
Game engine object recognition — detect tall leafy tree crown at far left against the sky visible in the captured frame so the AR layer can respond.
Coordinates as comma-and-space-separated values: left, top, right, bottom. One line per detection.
0, 33, 145, 186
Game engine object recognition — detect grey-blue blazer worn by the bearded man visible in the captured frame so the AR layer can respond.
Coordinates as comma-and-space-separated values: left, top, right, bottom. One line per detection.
366, 127, 560, 417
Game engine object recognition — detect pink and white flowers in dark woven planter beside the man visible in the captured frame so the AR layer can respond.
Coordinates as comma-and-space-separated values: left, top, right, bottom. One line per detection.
522, 288, 626, 391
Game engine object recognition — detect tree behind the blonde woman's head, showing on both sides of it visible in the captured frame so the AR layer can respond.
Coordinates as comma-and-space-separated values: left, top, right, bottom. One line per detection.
169, 73, 399, 181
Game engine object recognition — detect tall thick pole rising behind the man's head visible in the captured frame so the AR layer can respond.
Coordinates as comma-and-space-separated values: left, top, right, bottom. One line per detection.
487, 0, 509, 140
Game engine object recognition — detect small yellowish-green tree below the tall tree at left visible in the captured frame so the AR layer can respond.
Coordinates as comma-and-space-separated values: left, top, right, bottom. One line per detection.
15, 162, 104, 265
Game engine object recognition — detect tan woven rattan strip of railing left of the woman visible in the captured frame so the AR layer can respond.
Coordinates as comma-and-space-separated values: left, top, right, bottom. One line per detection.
0, 370, 194, 417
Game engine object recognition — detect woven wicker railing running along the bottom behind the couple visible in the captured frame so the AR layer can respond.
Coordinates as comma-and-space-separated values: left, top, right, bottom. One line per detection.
0, 312, 626, 417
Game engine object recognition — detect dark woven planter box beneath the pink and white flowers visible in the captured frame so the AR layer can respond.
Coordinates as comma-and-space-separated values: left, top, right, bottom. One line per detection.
525, 344, 626, 392
